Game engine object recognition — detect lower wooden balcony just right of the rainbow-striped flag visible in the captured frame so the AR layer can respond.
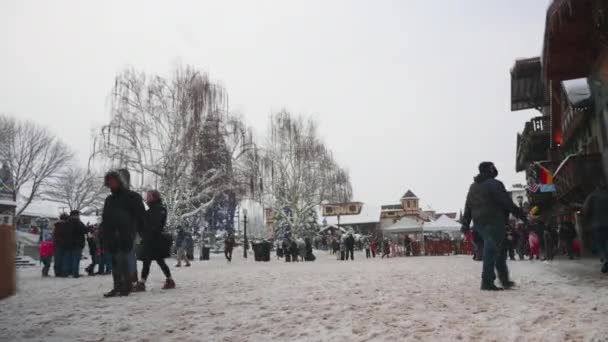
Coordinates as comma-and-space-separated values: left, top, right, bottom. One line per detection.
553, 153, 604, 205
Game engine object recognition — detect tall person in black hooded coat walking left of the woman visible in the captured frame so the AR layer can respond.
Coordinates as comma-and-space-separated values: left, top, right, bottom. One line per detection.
101, 170, 146, 297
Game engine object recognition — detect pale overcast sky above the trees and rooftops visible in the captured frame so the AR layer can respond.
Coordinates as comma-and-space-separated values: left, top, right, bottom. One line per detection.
0, 0, 549, 211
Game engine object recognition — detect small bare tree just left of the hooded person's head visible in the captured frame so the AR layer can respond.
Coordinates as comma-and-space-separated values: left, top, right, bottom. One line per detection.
41, 168, 105, 215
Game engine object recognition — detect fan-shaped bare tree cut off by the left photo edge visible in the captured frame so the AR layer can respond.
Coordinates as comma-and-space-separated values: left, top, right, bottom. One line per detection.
0, 115, 73, 219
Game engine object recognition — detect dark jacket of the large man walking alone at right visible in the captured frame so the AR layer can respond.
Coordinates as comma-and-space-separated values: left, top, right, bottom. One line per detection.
463, 175, 525, 228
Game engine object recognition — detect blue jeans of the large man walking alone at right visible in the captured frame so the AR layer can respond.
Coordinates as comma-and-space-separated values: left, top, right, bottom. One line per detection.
473, 225, 509, 287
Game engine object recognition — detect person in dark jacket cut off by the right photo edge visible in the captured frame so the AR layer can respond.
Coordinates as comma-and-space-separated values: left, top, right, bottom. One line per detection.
583, 183, 608, 273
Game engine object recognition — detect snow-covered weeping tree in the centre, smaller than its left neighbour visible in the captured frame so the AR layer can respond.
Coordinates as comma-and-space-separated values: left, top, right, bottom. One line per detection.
261, 111, 352, 238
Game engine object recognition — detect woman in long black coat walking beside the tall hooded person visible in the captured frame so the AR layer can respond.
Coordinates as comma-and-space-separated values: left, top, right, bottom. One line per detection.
133, 190, 175, 291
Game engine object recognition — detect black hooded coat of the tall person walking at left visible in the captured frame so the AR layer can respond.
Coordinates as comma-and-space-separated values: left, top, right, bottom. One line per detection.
101, 172, 146, 253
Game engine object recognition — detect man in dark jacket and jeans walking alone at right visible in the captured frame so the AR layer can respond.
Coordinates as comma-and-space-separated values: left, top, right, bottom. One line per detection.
462, 162, 526, 291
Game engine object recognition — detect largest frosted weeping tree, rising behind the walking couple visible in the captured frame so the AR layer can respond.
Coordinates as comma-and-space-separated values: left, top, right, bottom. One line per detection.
94, 67, 250, 225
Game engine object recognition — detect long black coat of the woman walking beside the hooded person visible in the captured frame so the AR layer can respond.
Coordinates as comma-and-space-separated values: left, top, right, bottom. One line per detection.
137, 200, 171, 260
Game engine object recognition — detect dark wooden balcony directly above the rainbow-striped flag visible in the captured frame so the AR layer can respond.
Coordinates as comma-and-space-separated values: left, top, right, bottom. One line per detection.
515, 116, 551, 172
